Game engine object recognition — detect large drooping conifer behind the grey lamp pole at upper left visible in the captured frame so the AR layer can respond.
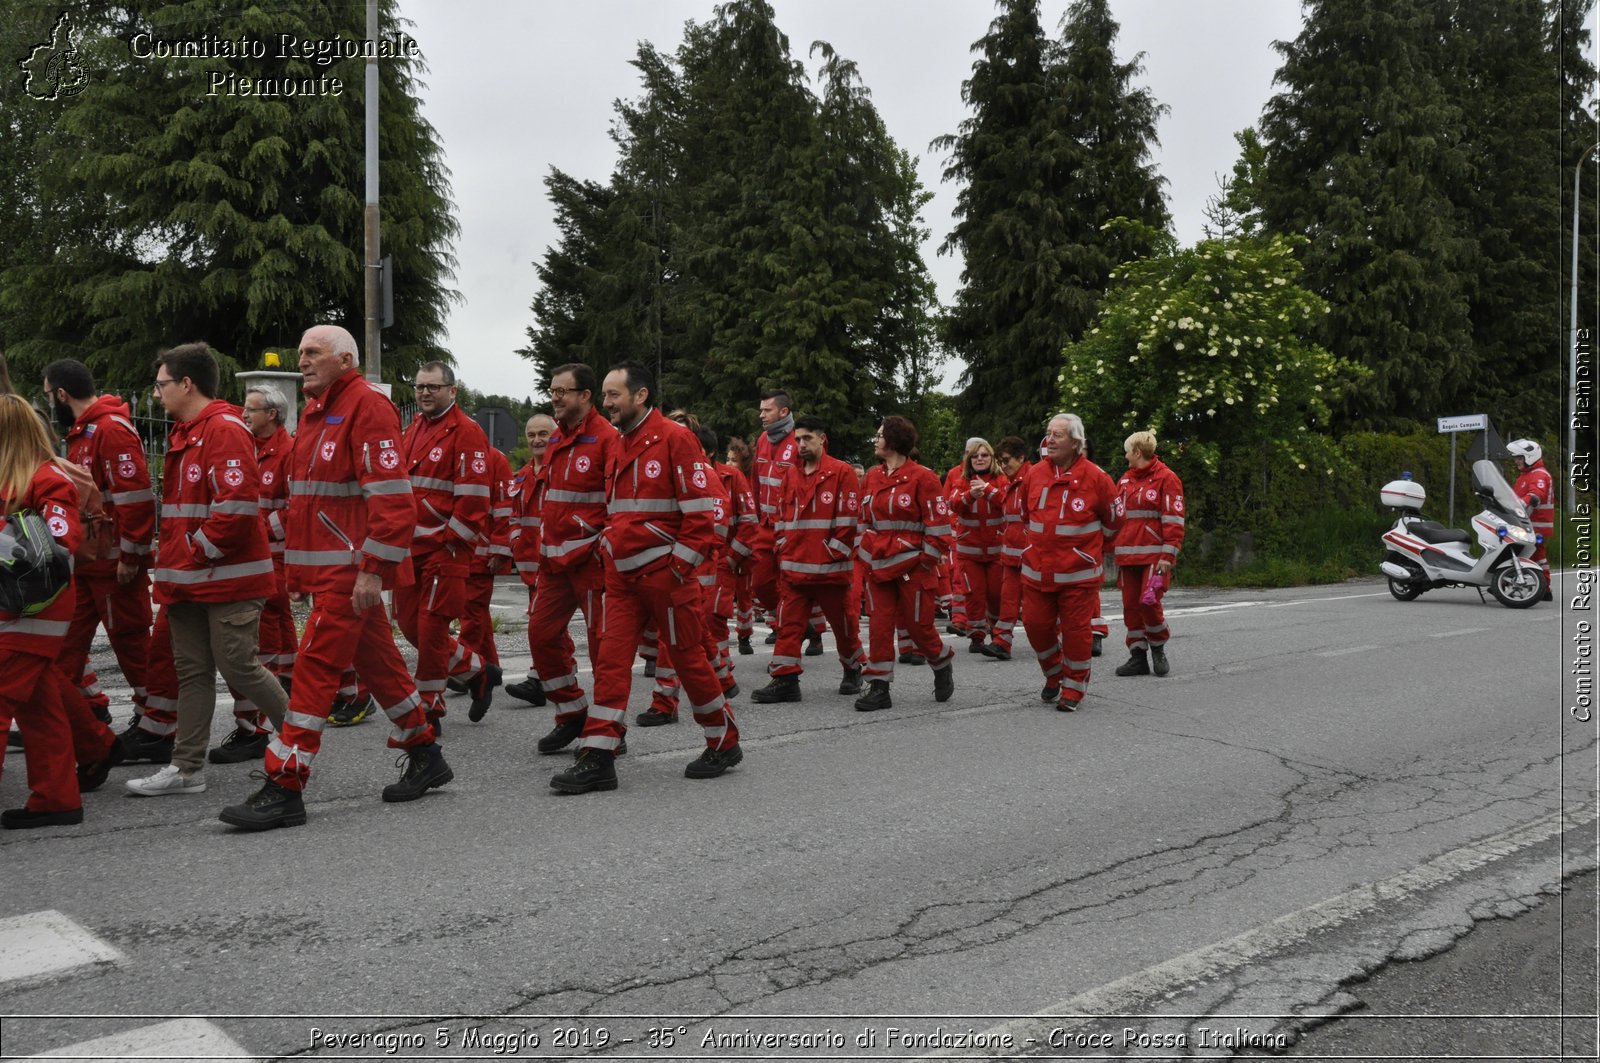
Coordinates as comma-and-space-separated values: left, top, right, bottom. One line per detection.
0, 0, 458, 386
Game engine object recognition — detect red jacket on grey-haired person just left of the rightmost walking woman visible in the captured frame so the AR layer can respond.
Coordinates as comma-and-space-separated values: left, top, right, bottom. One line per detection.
1022, 455, 1117, 591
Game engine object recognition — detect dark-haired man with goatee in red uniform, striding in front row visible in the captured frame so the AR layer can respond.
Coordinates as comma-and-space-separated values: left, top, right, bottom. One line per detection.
546, 362, 744, 794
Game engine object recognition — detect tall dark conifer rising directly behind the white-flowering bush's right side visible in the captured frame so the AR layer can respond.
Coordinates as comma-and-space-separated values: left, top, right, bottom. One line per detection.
1258, 0, 1477, 426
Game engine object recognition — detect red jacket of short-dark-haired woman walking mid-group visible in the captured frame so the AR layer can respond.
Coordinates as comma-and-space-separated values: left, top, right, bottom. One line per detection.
858, 459, 954, 583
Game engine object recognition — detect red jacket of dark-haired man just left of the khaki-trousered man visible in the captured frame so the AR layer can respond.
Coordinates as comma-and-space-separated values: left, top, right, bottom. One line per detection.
67, 395, 155, 576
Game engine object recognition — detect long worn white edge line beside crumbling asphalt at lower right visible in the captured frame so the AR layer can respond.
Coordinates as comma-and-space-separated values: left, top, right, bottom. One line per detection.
926, 807, 1600, 1058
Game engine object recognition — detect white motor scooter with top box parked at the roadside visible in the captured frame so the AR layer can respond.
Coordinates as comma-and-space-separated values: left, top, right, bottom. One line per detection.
1379, 461, 1544, 608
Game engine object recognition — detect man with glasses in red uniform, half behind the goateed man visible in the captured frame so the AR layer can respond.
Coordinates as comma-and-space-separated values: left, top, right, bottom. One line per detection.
528, 362, 617, 754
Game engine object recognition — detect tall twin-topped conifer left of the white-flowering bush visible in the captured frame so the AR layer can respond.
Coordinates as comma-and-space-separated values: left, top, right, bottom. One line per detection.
934, 0, 1168, 435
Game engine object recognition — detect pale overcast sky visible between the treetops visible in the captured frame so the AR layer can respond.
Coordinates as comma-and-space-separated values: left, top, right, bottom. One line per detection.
402, 0, 1301, 397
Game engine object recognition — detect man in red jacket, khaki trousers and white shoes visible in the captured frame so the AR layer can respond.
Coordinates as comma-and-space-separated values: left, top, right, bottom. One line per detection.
126, 343, 288, 797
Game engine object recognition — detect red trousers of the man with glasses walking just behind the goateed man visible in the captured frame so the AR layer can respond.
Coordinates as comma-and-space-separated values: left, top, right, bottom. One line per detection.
528, 557, 604, 724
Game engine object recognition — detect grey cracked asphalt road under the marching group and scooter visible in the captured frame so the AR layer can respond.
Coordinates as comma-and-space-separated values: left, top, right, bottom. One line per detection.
0, 581, 1597, 1058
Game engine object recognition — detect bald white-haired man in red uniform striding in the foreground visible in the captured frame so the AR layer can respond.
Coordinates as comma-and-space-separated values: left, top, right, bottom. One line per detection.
219, 325, 454, 831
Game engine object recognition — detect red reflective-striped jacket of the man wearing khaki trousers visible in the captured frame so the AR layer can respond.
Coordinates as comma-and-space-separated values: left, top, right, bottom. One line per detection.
154, 399, 278, 602
